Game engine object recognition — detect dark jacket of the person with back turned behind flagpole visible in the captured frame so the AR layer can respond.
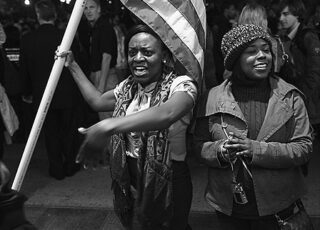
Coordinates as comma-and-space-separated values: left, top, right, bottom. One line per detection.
20, 24, 79, 109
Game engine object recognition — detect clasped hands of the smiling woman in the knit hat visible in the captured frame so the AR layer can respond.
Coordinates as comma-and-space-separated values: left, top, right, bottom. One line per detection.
221, 132, 253, 161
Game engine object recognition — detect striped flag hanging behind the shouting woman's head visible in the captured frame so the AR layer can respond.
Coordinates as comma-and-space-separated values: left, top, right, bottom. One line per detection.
121, 0, 206, 83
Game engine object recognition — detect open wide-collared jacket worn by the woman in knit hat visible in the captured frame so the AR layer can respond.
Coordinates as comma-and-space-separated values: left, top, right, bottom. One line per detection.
194, 76, 312, 216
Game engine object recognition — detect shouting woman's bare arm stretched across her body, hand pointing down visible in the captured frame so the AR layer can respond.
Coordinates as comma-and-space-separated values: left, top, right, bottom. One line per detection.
77, 92, 194, 168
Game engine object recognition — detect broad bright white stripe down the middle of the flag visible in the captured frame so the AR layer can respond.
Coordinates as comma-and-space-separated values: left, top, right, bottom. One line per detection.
143, 0, 204, 72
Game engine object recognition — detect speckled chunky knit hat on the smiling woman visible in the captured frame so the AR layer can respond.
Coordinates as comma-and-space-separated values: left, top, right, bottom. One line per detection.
221, 24, 271, 70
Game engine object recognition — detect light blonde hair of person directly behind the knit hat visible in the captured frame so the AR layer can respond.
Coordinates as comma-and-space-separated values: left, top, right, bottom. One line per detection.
238, 3, 268, 30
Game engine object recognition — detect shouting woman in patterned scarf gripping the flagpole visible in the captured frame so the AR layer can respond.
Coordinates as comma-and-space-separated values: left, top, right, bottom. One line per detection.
66, 24, 197, 230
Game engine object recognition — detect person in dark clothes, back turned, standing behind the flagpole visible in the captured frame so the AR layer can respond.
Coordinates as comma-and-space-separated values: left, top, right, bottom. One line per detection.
20, 0, 80, 180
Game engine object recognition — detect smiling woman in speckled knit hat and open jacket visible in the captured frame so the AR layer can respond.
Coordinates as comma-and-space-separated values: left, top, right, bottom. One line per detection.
195, 24, 312, 230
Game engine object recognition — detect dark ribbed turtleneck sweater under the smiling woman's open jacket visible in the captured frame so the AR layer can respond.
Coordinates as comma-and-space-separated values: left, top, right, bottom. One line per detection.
231, 76, 271, 218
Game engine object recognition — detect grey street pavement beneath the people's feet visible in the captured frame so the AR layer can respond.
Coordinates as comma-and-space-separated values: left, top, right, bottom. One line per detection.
4, 137, 320, 230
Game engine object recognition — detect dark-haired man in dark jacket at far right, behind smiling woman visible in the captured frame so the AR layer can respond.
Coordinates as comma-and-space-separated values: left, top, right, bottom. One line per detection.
280, 0, 320, 135
